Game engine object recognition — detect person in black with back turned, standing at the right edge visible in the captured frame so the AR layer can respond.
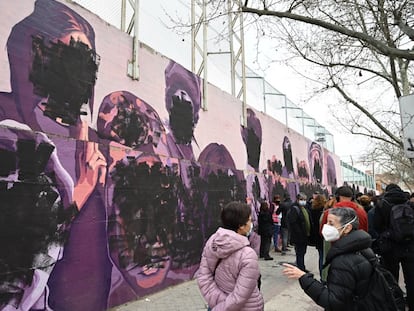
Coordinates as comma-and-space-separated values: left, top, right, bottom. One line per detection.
374, 184, 414, 311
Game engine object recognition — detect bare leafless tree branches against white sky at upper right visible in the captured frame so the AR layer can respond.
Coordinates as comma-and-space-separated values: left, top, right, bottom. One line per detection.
233, 0, 414, 180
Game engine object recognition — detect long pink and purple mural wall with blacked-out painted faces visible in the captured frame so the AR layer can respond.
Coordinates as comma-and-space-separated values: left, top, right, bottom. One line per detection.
0, 0, 340, 311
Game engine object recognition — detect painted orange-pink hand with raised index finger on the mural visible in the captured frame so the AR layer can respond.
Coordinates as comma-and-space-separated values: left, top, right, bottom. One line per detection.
73, 122, 106, 210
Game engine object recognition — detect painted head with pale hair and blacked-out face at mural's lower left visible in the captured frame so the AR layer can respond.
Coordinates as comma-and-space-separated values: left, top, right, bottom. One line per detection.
0, 123, 75, 310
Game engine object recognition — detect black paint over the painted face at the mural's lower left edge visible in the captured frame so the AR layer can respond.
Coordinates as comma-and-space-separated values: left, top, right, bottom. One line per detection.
0, 140, 70, 306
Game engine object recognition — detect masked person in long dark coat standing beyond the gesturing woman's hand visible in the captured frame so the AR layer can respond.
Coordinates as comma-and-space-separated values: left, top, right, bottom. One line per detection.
288, 193, 311, 271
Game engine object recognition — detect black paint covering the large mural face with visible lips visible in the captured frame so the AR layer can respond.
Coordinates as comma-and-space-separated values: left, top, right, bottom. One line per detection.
110, 159, 178, 268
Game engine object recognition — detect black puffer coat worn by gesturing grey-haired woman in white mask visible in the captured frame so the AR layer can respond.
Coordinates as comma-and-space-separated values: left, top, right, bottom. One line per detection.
299, 230, 375, 311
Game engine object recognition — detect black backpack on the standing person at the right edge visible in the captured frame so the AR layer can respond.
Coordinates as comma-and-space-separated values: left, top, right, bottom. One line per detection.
390, 202, 414, 242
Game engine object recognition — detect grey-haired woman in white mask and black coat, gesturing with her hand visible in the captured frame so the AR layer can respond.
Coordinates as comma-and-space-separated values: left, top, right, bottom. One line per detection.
283, 207, 375, 311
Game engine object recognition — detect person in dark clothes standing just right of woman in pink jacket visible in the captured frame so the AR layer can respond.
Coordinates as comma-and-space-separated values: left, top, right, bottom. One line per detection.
258, 201, 273, 260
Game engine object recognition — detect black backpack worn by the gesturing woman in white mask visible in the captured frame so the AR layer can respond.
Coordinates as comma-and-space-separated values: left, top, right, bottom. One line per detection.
354, 250, 405, 311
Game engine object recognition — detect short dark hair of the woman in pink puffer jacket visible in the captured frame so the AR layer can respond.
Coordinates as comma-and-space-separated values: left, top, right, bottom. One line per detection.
221, 202, 251, 232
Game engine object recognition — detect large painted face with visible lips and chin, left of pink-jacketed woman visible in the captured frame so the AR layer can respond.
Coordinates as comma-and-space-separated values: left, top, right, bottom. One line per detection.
110, 154, 179, 289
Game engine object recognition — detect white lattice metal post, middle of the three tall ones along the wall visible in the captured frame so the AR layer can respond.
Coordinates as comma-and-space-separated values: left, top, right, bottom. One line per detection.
191, 0, 208, 110
